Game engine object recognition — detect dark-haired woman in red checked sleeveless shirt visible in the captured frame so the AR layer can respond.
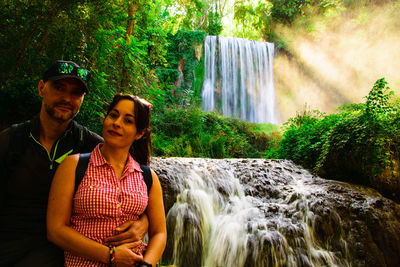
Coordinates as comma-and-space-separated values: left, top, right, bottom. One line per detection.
47, 95, 166, 266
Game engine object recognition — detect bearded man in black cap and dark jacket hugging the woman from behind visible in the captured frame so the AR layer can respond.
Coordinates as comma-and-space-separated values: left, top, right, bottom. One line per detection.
0, 60, 148, 266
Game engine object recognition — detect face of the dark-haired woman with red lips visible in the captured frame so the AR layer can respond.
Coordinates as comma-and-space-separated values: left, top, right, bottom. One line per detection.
103, 99, 143, 149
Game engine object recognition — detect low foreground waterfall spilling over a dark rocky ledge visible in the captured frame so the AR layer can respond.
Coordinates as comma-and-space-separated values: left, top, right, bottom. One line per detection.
151, 158, 400, 267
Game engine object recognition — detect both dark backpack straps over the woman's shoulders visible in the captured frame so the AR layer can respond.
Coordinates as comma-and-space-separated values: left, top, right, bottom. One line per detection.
74, 153, 153, 195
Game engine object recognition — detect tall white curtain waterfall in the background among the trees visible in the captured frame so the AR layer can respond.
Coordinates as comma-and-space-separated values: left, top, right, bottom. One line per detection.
201, 36, 279, 124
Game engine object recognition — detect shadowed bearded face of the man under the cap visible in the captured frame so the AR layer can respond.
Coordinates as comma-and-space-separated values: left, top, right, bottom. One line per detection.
39, 78, 85, 123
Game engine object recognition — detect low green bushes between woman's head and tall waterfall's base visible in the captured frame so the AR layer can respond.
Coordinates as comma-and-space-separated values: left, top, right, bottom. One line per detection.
153, 106, 277, 158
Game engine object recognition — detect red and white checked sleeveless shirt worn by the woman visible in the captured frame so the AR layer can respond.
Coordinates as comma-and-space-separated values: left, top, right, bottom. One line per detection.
65, 144, 148, 267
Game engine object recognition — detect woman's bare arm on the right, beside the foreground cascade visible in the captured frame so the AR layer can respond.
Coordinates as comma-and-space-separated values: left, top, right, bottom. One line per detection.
144, 171, 167, 266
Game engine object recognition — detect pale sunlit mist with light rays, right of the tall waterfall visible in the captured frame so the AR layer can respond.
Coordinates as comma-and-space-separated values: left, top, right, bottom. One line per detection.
274, 3, 400, 122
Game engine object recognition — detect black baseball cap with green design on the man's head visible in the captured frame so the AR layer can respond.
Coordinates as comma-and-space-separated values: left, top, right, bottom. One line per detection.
43, 60, 90, 93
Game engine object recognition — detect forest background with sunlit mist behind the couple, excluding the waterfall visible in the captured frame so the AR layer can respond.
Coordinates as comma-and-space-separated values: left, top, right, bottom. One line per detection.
0, 0, 400, 199
